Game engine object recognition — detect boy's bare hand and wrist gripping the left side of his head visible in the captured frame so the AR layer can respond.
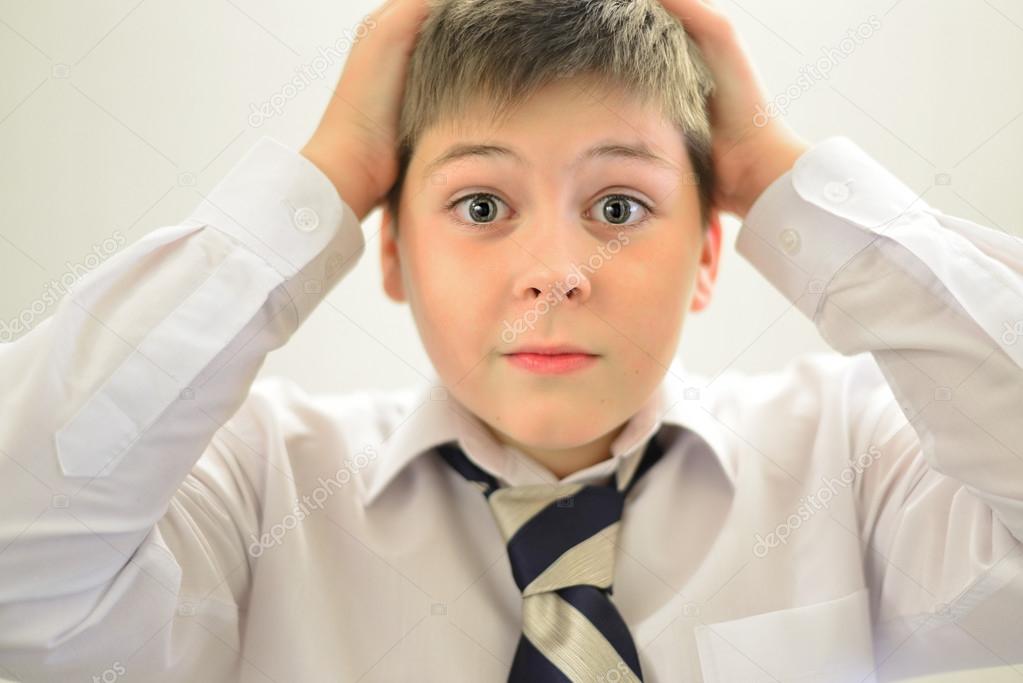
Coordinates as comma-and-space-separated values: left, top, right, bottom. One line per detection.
302, 0, 429, 221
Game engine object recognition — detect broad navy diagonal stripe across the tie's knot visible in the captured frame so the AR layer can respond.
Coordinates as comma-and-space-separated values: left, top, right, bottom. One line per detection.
507, 487, 624, 590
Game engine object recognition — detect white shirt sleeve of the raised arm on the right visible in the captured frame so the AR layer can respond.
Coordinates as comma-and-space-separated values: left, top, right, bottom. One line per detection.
736, 137, 1023, 642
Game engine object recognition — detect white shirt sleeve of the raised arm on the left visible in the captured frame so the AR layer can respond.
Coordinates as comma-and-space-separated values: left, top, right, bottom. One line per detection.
0, 138, 365, 680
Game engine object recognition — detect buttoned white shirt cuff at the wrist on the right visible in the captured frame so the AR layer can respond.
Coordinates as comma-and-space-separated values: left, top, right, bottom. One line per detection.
736, 136, 928, 322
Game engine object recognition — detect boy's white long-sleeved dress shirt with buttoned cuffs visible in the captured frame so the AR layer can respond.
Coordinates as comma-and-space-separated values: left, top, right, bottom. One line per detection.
0, 137, 1023, 683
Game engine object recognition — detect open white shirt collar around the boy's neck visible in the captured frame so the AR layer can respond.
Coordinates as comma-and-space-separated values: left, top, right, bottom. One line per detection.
363, 359, 736, 506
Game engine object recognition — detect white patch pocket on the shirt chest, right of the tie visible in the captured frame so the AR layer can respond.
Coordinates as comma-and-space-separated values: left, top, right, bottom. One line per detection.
694, 588, 877, 683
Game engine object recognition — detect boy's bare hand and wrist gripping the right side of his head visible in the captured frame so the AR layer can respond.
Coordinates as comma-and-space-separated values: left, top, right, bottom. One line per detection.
660, 0, 809, 218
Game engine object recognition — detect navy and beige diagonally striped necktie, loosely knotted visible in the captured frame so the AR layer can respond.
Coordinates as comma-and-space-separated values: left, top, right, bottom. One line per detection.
437, 435, 664, 683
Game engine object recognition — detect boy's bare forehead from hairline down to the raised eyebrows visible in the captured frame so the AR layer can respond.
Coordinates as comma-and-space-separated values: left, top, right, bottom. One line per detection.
409, 79, 688, 176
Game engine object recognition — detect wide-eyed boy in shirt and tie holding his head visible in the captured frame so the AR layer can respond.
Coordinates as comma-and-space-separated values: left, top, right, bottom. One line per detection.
0, 0, 1023, 681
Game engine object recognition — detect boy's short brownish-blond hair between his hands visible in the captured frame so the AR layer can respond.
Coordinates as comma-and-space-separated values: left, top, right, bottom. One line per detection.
387, 0, 714, 232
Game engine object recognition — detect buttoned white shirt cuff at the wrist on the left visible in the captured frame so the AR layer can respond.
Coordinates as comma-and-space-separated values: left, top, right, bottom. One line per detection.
188, 137, 365, 279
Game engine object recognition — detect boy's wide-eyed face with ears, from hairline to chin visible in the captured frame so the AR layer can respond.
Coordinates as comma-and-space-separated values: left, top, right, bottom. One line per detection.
381, 80, 720, 464
